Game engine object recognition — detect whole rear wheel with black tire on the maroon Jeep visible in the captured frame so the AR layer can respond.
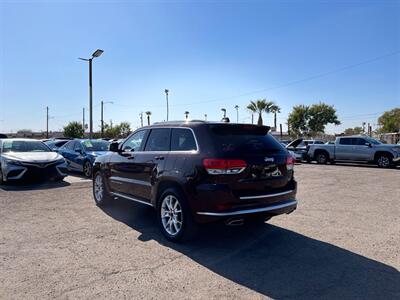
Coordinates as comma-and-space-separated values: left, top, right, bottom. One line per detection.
157, 188, 198, 243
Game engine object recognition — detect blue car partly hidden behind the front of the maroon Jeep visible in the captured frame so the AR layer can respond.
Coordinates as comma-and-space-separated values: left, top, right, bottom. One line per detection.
58, 139, 110, 178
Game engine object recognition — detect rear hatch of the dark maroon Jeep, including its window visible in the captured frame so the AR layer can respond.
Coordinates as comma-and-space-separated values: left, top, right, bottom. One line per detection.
208, 124, 294, 199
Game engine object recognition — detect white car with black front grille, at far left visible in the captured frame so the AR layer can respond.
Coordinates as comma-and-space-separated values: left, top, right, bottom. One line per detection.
0, 139, 67, 184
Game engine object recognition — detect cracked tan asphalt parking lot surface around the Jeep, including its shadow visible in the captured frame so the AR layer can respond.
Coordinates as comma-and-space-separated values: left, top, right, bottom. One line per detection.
0, 164, 400, 299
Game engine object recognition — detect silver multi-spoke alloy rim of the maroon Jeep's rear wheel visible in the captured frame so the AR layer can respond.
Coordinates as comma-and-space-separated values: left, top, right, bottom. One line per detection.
161, 195, 183, 236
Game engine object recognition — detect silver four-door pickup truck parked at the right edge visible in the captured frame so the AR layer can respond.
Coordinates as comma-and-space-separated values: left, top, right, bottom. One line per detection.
308, 135, 400, 168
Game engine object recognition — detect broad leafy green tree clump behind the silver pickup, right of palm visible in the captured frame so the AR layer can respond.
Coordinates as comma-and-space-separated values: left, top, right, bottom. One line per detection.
288, 102, 340, 136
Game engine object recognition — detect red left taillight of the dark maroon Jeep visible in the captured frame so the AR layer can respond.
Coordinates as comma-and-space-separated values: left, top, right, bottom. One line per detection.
203, 158, 247, 175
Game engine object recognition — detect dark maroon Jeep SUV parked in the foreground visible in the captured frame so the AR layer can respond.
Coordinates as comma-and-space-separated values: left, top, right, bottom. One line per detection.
93, 121, 297, 241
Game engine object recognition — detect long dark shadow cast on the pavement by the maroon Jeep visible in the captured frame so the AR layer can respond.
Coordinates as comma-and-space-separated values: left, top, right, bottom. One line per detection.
104, 200, 400, 299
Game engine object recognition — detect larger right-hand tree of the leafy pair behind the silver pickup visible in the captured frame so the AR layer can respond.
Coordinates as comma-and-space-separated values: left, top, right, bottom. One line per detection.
308, 102, 340, 135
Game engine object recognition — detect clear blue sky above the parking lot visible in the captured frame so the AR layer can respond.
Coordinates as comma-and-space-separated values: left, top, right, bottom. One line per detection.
0, 0, 400, 132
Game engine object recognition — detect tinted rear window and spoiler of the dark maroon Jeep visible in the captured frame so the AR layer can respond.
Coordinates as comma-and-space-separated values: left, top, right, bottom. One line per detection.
210, 125, 285, 155
